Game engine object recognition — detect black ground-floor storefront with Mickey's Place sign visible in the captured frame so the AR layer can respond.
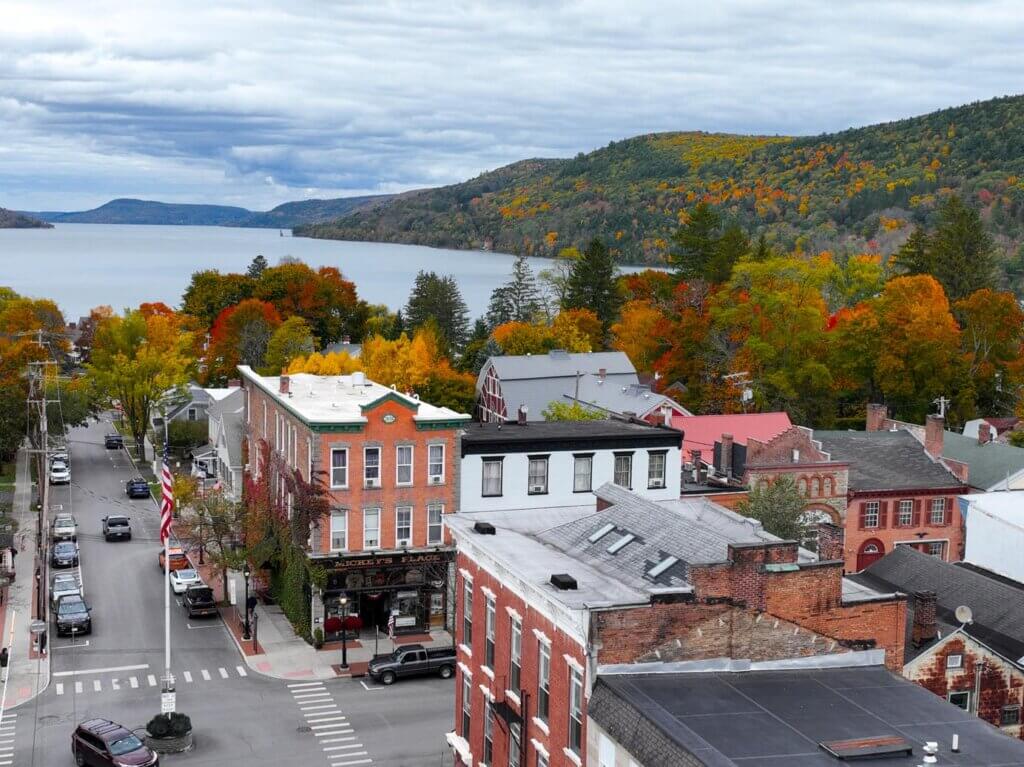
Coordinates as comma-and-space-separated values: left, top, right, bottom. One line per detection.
319, 551, 453, 641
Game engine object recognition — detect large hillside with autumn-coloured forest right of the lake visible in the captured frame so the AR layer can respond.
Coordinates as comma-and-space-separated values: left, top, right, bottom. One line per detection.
295, 96, 1024, 269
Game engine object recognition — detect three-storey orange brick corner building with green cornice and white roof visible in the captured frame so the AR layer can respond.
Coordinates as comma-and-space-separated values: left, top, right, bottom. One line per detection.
239, 366, 469, 638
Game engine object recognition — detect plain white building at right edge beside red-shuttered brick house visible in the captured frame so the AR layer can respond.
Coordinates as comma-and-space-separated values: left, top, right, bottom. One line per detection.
959, 491, 1024, 583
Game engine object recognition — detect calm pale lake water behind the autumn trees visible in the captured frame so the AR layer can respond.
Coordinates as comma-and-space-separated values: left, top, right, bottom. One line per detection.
0, 224, 633, 319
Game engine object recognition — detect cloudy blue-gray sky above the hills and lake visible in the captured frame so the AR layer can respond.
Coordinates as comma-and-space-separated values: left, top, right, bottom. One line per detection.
0, 0, 1024, 210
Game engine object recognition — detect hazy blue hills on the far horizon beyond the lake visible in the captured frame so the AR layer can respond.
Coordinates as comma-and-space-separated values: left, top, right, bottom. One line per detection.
35, 195, 390, 228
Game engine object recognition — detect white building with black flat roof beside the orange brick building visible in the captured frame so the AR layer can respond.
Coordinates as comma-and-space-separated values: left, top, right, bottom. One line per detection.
459, 418, 683, 512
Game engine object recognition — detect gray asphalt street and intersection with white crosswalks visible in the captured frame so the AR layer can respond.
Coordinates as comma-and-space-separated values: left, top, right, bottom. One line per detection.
8, 423, 454, 767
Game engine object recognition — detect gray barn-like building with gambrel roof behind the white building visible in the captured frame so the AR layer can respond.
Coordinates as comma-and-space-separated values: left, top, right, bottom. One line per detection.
476, 349, 688, 423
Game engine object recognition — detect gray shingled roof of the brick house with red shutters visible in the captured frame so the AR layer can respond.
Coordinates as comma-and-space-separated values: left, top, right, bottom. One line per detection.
814, 429, 964, 492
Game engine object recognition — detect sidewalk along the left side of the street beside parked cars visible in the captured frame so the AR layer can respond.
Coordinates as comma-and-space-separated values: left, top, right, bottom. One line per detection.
0, 450, 50, 709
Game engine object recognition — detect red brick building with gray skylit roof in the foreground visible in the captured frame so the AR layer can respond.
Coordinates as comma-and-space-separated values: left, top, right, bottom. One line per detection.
447, 484, 905, 767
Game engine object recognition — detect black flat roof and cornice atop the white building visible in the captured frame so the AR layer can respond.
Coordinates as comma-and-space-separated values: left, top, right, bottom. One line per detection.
462, 418, 683, 456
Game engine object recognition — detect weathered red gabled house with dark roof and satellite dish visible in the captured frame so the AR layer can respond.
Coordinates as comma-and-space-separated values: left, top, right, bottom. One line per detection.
854, 546, 1024, 738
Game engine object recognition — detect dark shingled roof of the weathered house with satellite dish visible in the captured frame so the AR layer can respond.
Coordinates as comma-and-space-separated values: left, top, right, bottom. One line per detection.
857, 546, 1024, 661
